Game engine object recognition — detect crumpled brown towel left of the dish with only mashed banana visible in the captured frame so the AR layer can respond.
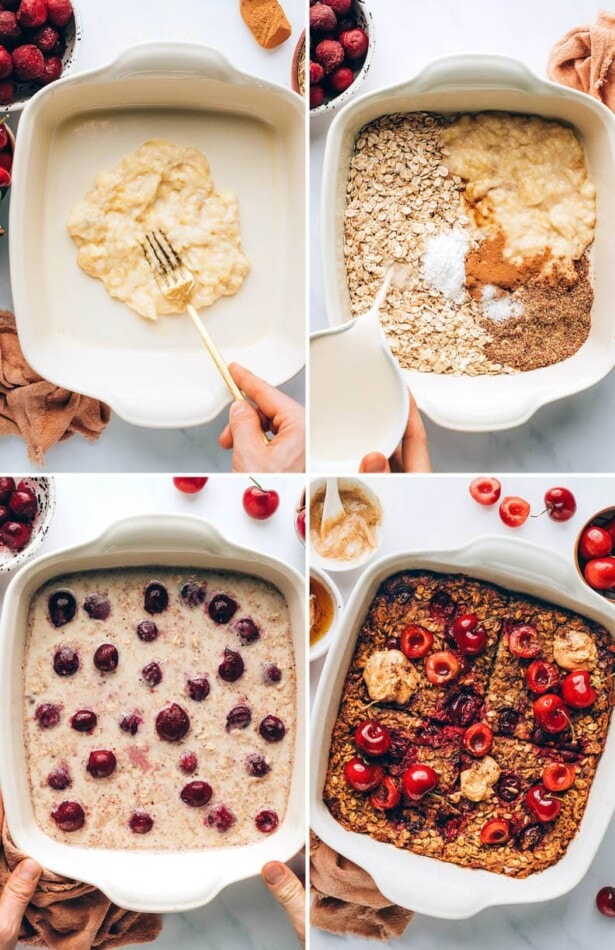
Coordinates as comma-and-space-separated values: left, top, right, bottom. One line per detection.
0, 310, 111, 466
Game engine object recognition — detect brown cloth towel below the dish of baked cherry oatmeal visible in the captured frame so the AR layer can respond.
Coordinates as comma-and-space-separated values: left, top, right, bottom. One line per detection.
310, 832, 414, 940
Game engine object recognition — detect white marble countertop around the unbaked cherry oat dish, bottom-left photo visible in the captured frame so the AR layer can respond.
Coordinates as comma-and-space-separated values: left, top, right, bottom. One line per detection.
0, 475, 305, 950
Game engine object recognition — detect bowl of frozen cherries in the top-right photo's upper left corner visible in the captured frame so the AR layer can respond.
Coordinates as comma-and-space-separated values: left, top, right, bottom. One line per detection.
309, 0, 374, 115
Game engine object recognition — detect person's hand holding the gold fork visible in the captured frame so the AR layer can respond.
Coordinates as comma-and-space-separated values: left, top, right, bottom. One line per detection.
220, 363, 305, 472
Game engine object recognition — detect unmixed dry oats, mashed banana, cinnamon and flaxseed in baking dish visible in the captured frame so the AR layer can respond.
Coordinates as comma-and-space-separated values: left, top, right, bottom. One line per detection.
344, 112, 596, 376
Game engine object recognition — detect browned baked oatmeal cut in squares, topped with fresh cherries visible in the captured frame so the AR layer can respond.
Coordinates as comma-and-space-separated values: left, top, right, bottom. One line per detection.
323, 571, 615, 877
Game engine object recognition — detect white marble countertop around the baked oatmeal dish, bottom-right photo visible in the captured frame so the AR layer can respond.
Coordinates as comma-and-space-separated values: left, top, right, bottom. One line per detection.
311, 475, 615, 950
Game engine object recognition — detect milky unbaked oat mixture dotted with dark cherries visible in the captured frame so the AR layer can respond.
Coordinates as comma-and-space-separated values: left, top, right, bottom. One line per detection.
23, 567, 296, 850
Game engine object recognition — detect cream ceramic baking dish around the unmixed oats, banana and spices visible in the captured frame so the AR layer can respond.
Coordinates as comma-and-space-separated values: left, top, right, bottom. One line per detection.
321, 54, 615, 432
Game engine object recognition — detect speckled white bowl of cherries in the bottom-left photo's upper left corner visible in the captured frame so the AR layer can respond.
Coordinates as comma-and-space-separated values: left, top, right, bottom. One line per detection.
0, 475, 55, 574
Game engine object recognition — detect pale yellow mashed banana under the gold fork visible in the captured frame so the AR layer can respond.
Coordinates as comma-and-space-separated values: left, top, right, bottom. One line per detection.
68, 140, 250, 320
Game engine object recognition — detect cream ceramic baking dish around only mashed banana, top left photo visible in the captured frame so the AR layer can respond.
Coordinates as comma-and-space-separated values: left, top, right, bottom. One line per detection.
10, 43, 305, 428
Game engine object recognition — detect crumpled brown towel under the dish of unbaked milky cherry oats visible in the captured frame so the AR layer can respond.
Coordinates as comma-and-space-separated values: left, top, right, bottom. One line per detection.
0, 822, 162, 950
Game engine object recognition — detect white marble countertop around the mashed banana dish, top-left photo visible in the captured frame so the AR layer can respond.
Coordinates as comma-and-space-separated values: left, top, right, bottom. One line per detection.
0, 0, 305, 472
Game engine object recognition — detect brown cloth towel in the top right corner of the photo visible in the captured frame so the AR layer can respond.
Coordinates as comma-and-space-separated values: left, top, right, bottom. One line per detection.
547, 10, 615, 112
